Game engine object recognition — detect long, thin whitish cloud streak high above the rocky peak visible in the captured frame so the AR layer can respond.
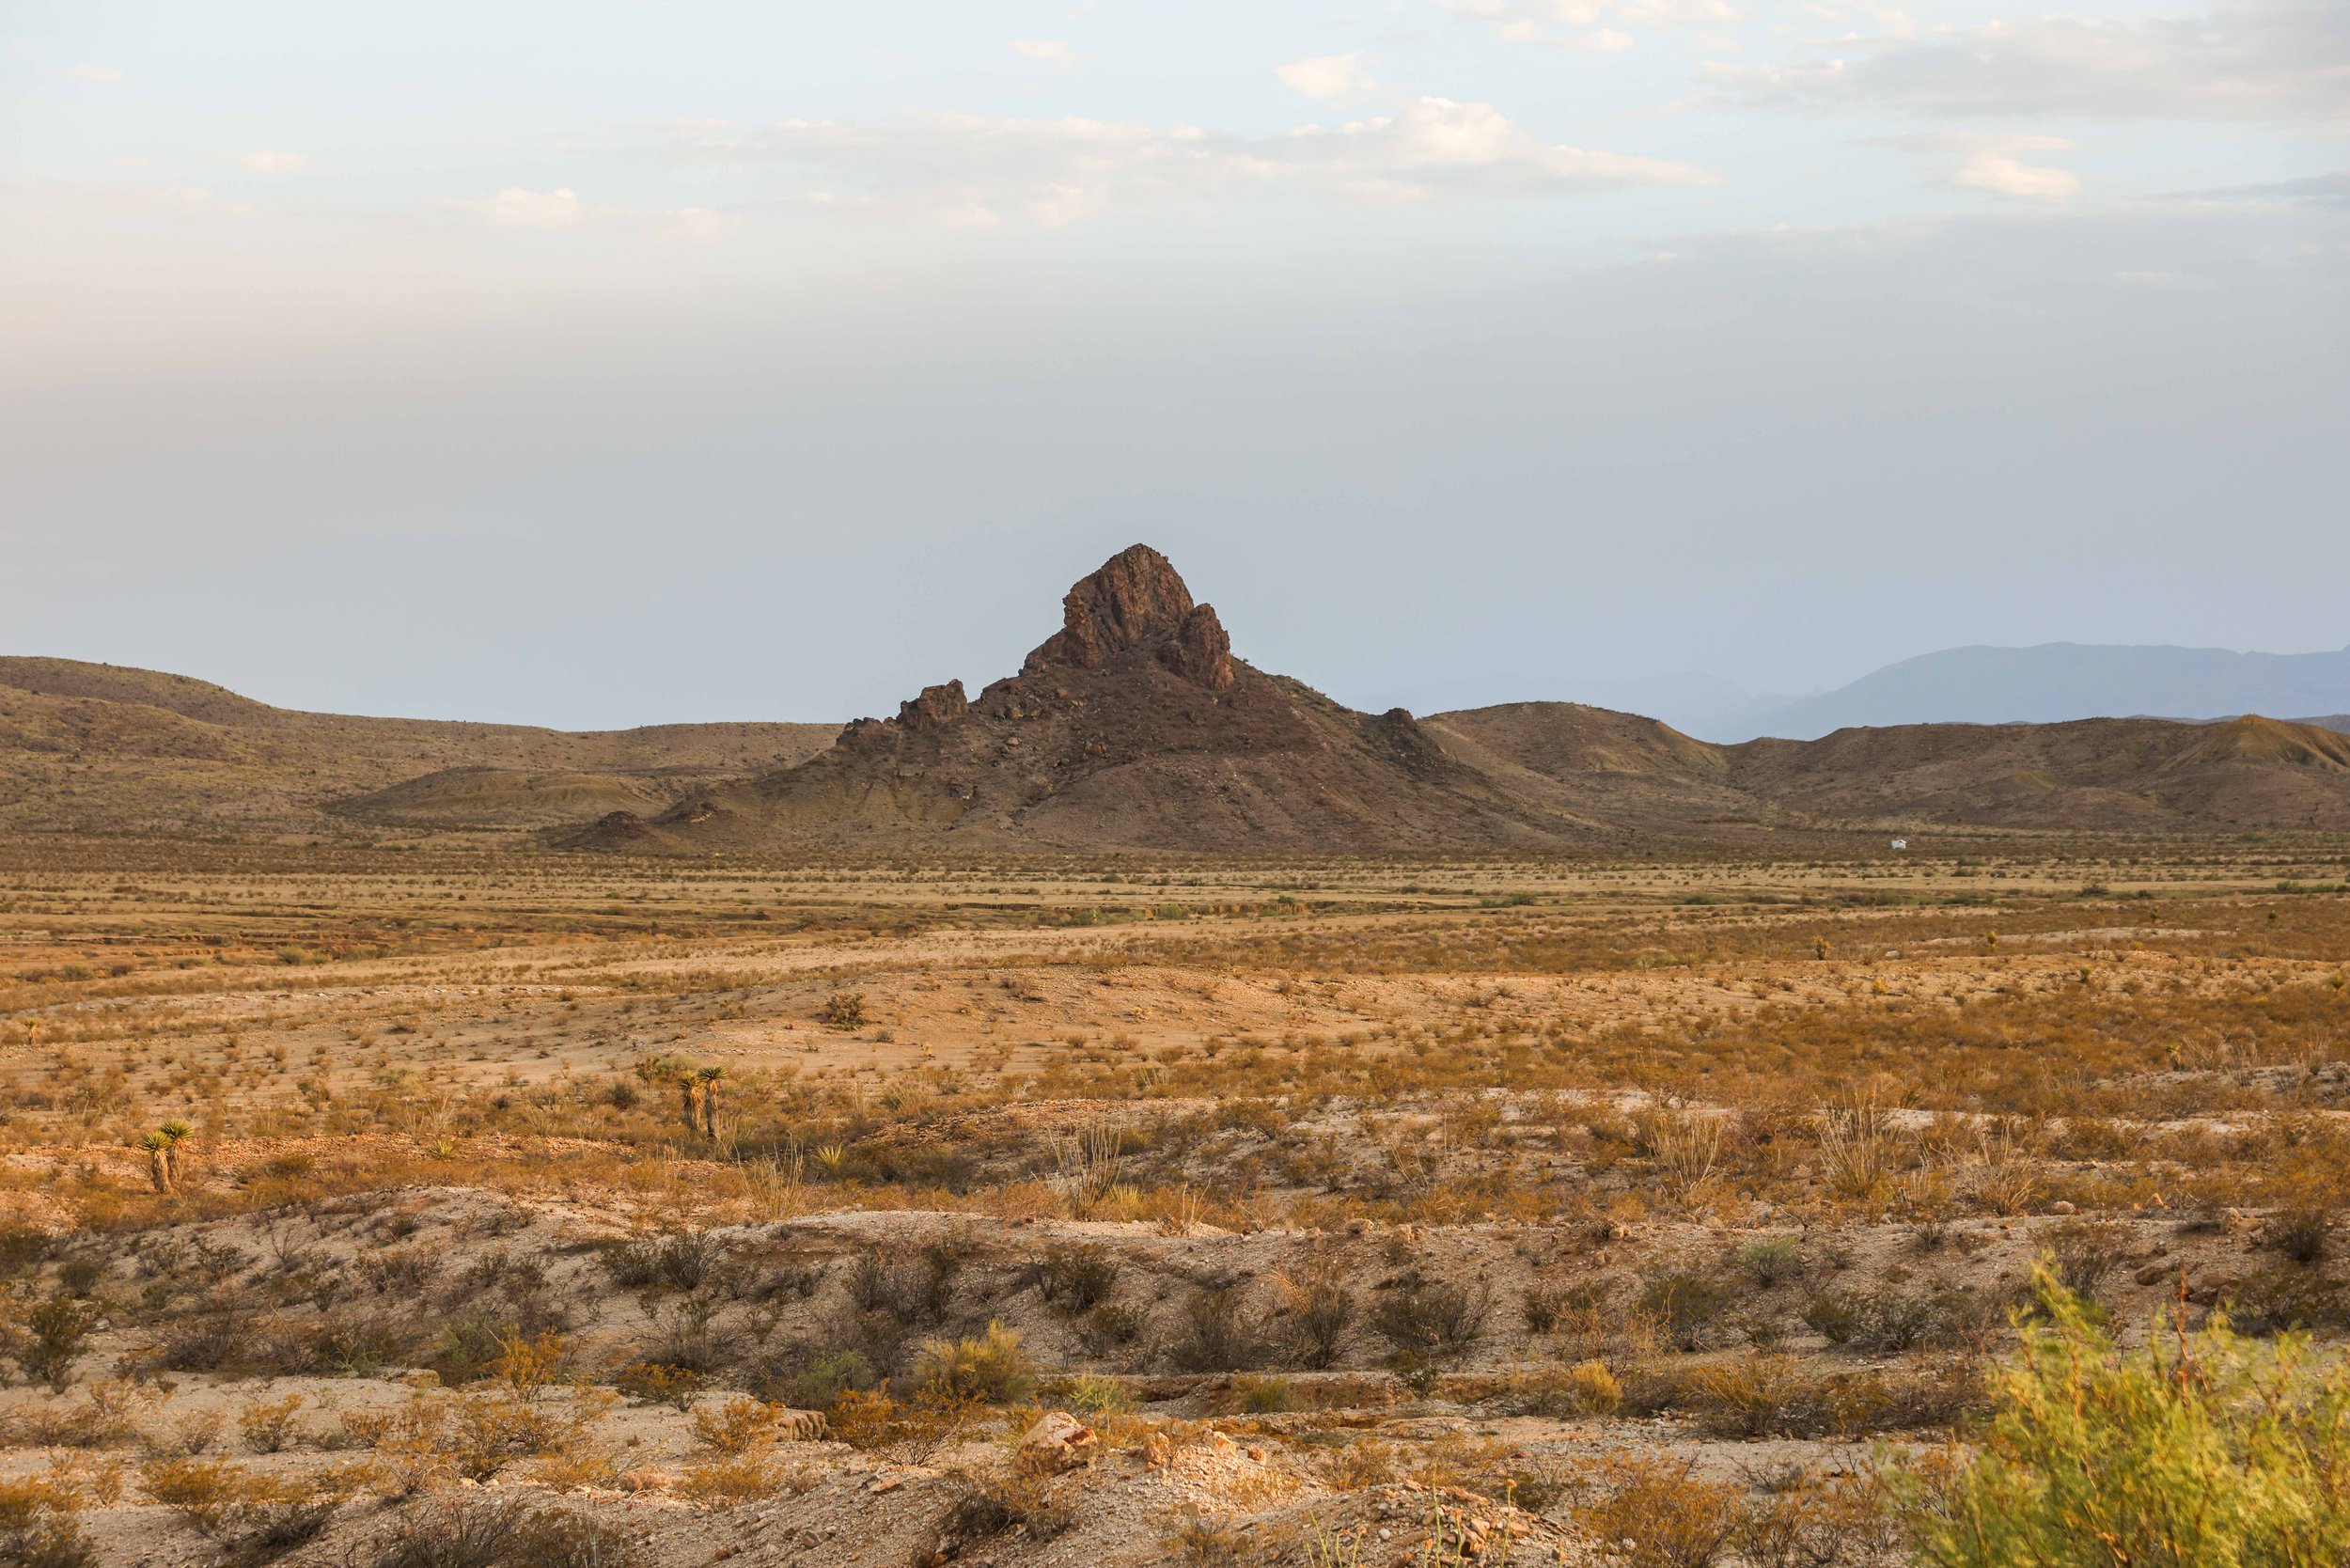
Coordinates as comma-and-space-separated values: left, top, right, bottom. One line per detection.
680, 99, 1720, 228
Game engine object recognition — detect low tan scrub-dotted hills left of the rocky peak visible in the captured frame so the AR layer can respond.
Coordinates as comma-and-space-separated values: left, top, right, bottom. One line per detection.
0, 658, 837, 832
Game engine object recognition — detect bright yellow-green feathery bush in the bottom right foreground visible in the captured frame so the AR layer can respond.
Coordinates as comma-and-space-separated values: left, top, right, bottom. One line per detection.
1922, 1267, 2350, 1568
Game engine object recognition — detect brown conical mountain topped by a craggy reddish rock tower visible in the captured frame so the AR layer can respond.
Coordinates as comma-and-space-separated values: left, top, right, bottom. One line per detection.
592, 545, 1596, 851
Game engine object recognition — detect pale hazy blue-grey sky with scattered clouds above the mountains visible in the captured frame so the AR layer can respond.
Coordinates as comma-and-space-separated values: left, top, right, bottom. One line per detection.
0, 0, 2350, 727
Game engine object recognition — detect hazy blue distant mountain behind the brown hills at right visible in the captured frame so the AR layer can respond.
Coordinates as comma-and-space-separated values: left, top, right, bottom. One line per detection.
1587, 642, 2350, 743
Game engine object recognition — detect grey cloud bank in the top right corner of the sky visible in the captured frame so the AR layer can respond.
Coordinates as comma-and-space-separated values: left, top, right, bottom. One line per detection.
1716, 0, 2350, 122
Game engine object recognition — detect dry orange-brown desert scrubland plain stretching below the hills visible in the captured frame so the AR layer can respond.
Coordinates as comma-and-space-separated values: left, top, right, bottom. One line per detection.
0, 835, 2350, 1568
